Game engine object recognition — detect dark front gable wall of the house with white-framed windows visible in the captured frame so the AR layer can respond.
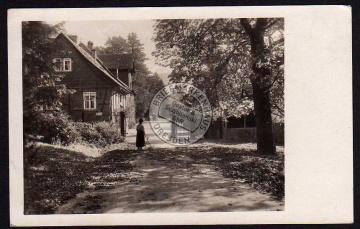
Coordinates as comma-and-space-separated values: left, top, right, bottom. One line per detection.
49, 34, 130, 122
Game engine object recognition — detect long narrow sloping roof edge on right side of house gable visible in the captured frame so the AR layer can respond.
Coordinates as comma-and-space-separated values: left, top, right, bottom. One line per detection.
58, 33, 130, 93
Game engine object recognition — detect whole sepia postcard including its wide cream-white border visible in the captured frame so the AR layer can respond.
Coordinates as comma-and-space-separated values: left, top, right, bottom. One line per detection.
8, 6, 353, 226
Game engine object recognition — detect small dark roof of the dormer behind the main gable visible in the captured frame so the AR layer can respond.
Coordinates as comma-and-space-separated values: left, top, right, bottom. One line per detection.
98, 54, 134, 70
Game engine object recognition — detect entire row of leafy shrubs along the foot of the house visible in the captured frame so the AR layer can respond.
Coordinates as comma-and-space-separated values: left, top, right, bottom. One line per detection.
36, 112, 124, 147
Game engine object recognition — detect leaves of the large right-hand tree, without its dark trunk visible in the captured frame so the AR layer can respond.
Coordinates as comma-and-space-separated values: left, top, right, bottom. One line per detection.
153, 19, 284, 117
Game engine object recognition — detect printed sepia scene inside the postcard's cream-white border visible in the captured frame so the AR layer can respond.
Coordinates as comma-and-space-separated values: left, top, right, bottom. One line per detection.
21, 18, 286, 215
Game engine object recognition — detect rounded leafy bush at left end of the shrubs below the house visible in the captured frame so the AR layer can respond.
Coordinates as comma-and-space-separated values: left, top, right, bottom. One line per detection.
36, 112, 80, 145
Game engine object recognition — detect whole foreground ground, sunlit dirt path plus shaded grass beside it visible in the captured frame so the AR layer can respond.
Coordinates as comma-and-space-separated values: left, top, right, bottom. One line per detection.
25, 145, 284, 214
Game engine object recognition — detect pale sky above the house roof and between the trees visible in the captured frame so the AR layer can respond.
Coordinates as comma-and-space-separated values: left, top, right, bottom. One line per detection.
50, 20, 171, 83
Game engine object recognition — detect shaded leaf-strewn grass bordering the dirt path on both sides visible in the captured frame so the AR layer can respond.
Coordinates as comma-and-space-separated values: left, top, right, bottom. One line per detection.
24, 145, 284, 214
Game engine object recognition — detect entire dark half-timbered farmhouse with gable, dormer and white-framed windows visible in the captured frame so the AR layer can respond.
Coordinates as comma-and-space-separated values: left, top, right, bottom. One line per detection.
52, 33, 135, 135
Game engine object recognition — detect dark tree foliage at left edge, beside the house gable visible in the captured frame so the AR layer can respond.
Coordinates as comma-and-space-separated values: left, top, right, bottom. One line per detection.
22, 21, 69, 137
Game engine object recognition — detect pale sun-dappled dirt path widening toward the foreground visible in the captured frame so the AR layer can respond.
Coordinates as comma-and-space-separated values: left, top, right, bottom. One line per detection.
56, 150, 284, 214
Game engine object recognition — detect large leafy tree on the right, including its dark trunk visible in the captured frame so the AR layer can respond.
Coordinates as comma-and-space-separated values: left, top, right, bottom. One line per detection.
153, 18, 284, 154
